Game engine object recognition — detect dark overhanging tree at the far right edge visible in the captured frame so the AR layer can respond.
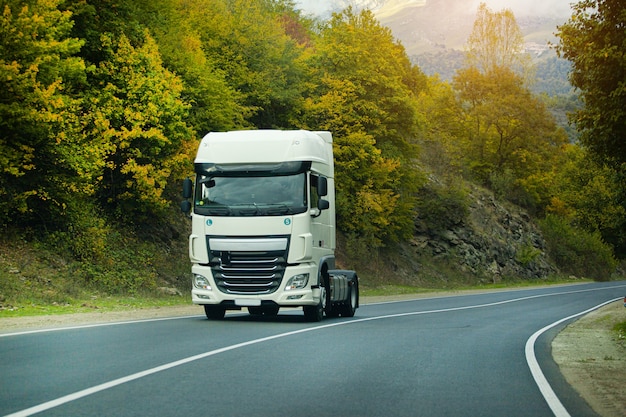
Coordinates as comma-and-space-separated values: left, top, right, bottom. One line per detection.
556, 0, 626, 258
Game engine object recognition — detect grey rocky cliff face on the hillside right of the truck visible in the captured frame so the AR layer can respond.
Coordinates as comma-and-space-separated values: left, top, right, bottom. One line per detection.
411, 188, 557, 282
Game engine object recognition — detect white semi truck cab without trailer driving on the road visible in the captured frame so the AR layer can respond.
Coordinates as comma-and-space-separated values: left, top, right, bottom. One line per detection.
182, 130, 359, 321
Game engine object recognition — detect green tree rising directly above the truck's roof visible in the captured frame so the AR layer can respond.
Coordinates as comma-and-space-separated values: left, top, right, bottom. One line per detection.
178, 0, 305, 128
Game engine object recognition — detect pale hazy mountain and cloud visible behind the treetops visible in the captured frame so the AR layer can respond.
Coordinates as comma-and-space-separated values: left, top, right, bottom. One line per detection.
298, 0, 571, 95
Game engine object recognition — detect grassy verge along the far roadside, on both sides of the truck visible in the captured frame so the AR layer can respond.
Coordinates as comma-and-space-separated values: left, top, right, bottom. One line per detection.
0, 228, 604, 319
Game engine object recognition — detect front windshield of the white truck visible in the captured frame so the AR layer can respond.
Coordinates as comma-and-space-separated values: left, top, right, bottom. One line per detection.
194, 173, 307, 216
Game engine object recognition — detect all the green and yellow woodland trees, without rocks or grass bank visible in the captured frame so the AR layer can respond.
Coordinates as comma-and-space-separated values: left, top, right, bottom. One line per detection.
0, 0, 626, 291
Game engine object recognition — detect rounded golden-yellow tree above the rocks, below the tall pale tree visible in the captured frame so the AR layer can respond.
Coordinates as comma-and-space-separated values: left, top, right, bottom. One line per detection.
454, 67, 566, 198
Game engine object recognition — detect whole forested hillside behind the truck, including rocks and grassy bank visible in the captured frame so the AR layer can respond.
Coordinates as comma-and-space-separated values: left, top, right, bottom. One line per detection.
0, 0, 626, 306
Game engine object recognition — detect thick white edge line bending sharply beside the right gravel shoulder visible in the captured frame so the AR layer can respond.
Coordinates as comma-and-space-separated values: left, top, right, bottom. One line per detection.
525, 297, 622, 417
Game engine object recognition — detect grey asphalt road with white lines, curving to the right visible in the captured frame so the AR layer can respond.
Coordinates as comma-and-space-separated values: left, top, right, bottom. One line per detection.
0, 281, 626, 417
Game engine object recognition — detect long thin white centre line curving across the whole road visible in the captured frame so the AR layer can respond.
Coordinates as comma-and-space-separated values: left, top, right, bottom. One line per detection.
5, 285, 626, 417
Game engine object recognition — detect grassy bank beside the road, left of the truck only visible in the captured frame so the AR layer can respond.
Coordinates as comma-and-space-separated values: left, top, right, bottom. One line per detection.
0, 226, 191, 318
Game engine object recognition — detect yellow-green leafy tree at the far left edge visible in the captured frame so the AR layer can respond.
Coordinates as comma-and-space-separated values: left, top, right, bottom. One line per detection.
0, 0, 97, 227
